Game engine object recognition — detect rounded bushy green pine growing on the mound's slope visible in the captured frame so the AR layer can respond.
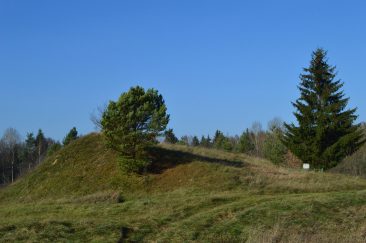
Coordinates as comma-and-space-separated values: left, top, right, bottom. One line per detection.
101, 86, 169, 172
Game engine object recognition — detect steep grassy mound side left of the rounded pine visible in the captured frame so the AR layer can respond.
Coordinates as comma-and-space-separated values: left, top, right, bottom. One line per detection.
0, 134, 143, 201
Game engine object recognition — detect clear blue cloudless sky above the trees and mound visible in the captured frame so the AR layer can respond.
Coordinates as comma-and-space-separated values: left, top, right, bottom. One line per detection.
0, 0, 366, 139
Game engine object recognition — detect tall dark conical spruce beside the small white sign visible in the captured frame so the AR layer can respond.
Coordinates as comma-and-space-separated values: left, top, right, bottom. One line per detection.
283, 49, 365, 169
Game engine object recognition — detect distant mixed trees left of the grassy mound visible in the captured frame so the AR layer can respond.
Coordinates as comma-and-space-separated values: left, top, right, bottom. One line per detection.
0, 127, 78, 185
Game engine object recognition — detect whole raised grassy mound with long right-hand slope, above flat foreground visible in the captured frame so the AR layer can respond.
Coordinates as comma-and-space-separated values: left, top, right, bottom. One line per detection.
0, 134, 364, 201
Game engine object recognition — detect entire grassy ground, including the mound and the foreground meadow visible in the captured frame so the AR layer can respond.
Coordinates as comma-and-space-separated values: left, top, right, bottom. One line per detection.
0, 134, 366, 242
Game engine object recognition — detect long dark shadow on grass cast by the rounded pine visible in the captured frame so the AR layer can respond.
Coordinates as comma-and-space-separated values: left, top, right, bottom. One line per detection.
149, 147, 245, 174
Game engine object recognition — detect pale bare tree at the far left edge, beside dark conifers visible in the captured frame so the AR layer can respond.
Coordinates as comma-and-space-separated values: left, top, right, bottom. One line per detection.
1, 128, 20, 183
